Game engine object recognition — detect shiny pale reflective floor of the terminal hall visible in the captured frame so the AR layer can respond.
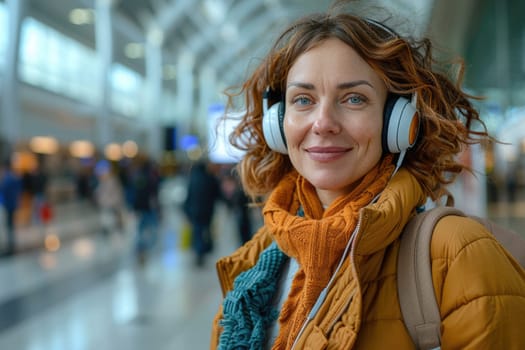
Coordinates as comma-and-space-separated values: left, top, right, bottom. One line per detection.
0, 178, 242, 350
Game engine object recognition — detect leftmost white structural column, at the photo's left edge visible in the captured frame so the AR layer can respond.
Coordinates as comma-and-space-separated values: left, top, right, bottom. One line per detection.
0, 0, 27, 145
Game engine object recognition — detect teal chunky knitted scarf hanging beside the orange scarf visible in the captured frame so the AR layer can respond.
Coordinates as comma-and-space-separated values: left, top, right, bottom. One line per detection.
218, 242, 288, 350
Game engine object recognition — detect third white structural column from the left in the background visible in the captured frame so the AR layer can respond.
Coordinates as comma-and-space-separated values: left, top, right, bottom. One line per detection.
144, 28, 163, 159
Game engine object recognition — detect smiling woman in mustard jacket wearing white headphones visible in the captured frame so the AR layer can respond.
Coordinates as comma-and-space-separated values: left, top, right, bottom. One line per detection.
211, 5, 525, 349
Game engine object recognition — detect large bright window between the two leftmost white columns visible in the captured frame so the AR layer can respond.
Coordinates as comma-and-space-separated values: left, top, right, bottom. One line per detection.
19, 17, 100, 103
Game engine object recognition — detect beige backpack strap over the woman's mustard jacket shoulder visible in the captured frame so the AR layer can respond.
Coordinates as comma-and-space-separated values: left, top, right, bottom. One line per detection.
397, 207, 465, 349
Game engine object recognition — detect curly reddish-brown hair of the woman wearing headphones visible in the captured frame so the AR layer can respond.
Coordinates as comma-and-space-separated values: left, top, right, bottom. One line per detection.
223, 13, 490, 199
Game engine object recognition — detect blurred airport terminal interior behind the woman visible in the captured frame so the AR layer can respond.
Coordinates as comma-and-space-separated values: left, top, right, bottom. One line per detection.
0, 0, 525, 350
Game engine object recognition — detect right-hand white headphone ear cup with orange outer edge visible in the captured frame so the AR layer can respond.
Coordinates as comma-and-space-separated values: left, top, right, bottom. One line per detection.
382, 95, 419, 153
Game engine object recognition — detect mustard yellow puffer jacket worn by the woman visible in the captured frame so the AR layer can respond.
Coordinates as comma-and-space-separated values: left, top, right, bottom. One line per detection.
211, 170, 525, 350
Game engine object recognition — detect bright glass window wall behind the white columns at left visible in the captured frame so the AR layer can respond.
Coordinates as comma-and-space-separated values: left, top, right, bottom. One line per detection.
15, 15, 144, 118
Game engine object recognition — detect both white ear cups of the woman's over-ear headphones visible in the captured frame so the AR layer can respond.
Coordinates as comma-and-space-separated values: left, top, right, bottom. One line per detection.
263, 89, 420, 154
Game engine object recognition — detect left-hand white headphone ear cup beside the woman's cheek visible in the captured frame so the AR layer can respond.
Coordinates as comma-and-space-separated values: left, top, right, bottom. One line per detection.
263, 102, 288, 154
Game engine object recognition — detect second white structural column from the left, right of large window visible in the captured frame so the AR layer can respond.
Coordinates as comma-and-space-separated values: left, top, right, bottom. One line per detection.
95, 0, 113, 148
